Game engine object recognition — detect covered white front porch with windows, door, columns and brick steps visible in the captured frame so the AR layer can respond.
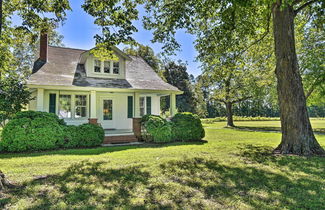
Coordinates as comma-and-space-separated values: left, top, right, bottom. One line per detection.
29, 88, 176, 142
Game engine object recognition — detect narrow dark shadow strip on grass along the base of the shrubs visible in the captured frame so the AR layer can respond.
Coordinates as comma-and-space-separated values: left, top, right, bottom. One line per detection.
0, 140, 208, 159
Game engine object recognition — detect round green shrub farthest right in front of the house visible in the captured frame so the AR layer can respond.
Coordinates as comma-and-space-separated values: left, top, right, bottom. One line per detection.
171, 112, 205, 141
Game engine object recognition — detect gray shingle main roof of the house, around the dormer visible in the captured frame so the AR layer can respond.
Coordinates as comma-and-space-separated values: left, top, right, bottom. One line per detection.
27, 46, 179, 91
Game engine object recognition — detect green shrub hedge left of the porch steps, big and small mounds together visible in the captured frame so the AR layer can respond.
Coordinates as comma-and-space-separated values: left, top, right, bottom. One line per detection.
0, 111, 105, 152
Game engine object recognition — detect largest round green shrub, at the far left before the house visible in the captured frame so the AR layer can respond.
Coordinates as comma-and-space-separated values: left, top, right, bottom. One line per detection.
0, 117, 64, 152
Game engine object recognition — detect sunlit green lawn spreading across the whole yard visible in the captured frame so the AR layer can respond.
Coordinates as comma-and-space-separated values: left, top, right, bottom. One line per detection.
0, 121, 325, 209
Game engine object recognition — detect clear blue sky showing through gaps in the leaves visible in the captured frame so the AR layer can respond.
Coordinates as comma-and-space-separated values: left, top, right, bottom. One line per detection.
58, 1, 201, 76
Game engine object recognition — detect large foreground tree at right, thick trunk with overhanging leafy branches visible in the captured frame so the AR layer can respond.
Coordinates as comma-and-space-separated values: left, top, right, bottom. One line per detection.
89, 0, 325, 155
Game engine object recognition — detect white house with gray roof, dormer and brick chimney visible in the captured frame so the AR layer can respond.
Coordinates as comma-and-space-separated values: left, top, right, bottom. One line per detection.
27, 34, 182, 144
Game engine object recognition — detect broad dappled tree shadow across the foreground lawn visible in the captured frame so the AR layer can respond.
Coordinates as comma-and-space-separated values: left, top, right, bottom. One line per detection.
0, 146, 325, 209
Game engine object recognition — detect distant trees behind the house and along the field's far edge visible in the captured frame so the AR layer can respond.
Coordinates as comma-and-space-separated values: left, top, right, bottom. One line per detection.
124, 44, 325, 118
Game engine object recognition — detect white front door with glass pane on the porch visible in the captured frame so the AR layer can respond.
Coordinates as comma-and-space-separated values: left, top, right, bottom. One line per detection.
100, 98, 115, 129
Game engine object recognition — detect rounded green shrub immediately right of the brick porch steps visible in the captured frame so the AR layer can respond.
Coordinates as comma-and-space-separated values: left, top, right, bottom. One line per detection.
141, 115, 173, 142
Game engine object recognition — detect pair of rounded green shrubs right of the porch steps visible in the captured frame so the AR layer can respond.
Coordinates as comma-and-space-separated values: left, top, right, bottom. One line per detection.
141, 112, 205, 142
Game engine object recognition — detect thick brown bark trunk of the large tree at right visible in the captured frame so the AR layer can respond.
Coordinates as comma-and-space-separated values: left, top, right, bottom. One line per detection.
272, 0, 325, 155
